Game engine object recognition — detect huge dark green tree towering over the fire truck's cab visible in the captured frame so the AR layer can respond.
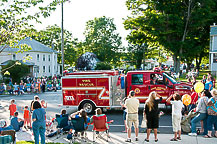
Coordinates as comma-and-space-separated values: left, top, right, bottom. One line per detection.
124, 0, 216, 72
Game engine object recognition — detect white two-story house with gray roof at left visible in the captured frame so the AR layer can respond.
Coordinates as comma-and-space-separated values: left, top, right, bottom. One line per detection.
0, 38, 60, 77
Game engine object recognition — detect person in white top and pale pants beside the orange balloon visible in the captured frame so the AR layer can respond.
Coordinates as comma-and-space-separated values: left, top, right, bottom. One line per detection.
166, 93, 184, 141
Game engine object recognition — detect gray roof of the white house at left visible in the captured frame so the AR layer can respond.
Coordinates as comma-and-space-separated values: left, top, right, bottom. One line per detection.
1, 37, 57, 53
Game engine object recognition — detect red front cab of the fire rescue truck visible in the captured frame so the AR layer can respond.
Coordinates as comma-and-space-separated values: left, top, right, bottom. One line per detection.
126, 71, 192, 104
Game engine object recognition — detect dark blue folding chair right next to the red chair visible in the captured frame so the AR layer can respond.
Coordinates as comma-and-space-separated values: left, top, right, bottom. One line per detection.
68, 117, 87, 143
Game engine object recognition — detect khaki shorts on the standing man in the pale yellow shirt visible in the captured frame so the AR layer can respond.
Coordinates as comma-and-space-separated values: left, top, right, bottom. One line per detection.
126, 113, 139, 128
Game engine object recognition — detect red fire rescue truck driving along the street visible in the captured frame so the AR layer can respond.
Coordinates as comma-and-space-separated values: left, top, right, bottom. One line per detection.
62, 71, 192, 113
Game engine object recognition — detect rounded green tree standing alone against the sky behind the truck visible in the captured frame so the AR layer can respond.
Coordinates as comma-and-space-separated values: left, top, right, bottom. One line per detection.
84, 16, 123, 65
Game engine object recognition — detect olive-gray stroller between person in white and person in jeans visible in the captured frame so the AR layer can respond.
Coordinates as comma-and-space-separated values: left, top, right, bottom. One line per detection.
181, 110, 198, 133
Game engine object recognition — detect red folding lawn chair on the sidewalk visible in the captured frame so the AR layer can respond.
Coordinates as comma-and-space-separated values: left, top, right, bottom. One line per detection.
93, 115, 113, 142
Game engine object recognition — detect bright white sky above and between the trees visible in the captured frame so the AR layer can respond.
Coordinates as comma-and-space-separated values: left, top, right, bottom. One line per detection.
35, 0, 130, 46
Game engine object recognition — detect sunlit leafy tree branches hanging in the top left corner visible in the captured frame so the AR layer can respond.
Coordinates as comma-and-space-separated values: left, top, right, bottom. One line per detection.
0, 0, 67, 53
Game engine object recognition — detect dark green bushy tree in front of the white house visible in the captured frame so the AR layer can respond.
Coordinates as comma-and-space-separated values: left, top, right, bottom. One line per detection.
2, 61, 30, 83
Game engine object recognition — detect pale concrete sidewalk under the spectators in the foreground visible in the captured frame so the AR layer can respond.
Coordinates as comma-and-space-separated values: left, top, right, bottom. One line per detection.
17, 131, 217, 144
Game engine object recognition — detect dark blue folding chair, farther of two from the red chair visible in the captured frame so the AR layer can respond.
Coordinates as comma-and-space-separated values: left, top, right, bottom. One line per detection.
56, 114, 69, 138
